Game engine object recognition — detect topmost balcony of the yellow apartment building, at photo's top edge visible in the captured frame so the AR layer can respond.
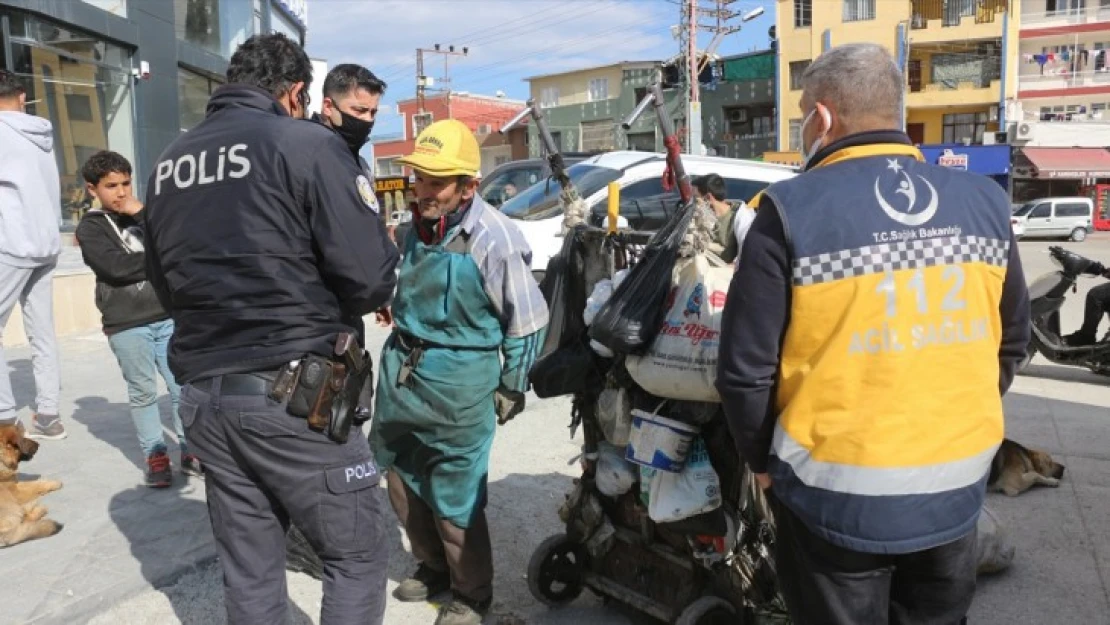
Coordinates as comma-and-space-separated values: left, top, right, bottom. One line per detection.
910, 0, 1009, 43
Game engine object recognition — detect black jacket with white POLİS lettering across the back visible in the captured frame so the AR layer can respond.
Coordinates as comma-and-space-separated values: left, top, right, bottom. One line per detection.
143, 84, 397, 383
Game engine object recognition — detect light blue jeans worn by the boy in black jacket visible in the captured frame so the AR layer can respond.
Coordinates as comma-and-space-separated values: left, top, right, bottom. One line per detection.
108, 319, 186, 457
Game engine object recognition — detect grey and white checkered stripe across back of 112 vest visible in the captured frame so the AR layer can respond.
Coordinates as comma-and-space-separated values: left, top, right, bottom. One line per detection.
794, 236, 1010, 286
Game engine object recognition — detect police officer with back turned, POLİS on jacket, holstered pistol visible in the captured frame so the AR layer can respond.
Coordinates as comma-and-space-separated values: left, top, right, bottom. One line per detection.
144, 33, 397, 624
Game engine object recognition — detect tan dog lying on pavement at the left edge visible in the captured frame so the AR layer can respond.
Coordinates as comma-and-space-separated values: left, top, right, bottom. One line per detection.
0, 424, 62, 548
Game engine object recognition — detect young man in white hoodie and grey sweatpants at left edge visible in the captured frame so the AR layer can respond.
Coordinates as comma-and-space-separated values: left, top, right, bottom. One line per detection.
0, 69, 65, 440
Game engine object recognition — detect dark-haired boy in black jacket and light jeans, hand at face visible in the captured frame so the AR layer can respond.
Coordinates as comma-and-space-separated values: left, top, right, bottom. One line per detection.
77, 151, 201, 488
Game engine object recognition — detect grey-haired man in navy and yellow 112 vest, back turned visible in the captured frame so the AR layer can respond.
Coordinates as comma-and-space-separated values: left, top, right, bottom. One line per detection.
717, 43, 1029, 625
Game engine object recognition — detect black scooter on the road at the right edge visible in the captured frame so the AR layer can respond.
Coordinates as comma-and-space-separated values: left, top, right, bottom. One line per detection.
1019, 245, 1110, 375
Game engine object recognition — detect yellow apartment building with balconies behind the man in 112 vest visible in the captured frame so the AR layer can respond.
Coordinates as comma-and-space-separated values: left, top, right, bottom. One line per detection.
775, 0, 1019, 160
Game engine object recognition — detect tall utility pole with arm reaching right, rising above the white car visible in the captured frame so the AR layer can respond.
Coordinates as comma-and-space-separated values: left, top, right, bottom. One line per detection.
679, 0, 763, 154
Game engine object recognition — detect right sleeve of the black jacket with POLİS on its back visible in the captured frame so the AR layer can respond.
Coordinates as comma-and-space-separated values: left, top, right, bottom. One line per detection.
305, 138, 398, 315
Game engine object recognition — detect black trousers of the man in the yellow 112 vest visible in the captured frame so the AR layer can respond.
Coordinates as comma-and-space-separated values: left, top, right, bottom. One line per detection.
768, 493, 977, 625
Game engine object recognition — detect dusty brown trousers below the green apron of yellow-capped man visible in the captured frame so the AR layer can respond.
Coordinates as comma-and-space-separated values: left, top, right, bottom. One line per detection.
385, 471, 493, 603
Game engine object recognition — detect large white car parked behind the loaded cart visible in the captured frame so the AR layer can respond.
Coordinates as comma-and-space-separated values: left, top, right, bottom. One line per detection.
501, 151, 796, 278
